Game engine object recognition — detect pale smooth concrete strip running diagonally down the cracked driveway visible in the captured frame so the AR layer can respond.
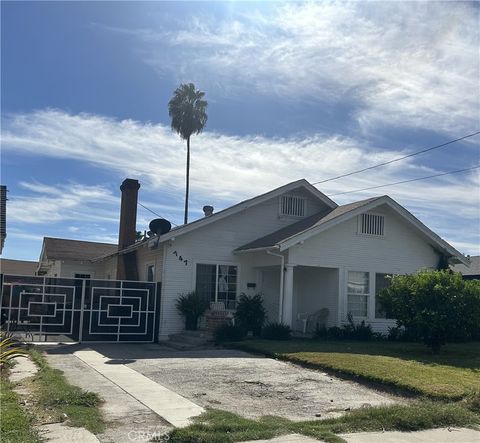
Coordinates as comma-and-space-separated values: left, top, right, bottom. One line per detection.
74, 349, 205, 427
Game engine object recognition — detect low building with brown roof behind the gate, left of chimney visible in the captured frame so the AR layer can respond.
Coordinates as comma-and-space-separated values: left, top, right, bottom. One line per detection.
37, 237, 118, 279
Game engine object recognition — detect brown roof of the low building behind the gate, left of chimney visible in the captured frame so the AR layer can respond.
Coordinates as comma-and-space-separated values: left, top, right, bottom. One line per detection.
41, 237, 118, 261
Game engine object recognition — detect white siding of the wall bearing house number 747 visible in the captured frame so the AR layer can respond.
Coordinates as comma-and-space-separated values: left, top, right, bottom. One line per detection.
160, 189, 325, 338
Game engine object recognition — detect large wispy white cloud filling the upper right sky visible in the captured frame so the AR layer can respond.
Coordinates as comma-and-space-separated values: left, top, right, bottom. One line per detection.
104, 2, 480, 134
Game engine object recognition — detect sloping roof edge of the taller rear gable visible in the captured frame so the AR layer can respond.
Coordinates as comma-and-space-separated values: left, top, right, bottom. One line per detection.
120, 179, 338, 253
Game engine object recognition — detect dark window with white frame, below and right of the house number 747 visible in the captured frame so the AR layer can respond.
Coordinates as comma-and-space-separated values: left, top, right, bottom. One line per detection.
196, 264, 238, 309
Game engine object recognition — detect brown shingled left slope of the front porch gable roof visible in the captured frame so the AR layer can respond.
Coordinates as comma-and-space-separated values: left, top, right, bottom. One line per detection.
235, 197, 380, 252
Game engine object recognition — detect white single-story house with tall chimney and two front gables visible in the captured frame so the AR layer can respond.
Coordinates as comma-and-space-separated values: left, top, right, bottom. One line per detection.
33, 179, 469, 339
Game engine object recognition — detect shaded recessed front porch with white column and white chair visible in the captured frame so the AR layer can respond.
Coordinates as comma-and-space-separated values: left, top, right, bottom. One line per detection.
257, 264, 340, 333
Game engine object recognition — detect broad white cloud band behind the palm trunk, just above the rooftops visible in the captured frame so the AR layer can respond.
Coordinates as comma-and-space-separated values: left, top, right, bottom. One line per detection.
2, 110, 480, 252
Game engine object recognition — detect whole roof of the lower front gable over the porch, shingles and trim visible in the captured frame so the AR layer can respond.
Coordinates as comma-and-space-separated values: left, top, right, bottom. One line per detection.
236, 195, 469, 266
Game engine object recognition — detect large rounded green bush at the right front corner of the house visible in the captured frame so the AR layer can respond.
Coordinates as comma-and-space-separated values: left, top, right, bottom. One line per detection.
379, 270, 480, 352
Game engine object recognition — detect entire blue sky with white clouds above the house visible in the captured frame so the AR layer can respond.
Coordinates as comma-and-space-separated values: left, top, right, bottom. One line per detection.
1, 1, 480, 259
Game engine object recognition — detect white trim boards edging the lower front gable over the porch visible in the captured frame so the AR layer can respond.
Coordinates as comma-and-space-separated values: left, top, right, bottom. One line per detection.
278, 195, 470, 266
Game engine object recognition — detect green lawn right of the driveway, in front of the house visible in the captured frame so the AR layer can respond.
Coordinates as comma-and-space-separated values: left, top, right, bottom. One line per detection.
232, 339, 480, 400
